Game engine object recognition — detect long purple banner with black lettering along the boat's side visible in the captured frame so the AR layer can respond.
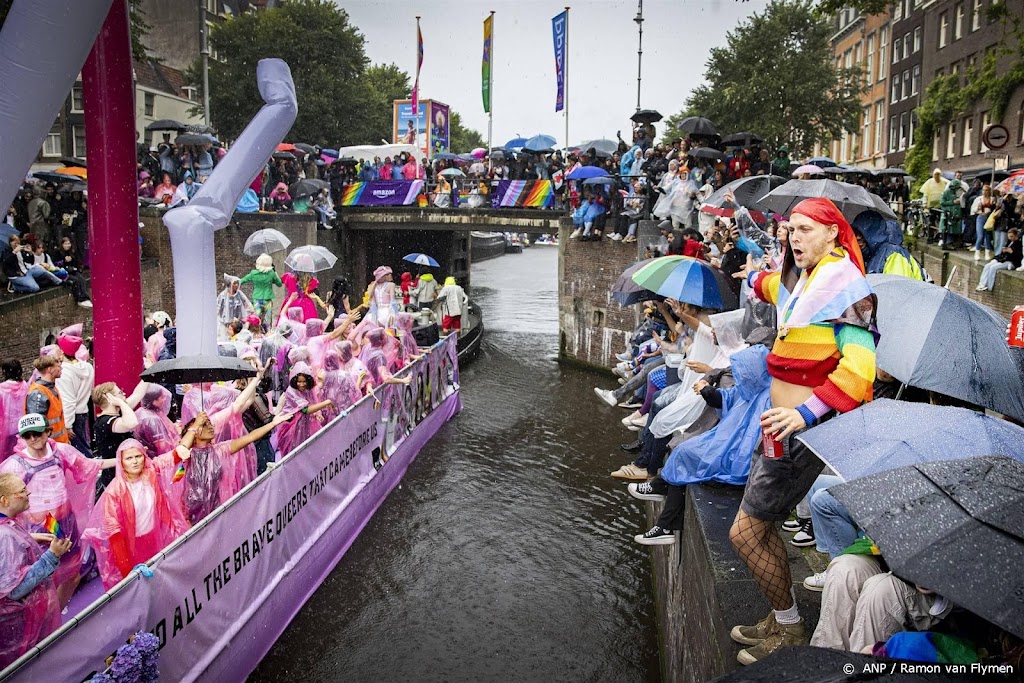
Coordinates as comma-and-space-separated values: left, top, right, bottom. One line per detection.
0, 336, 462, 681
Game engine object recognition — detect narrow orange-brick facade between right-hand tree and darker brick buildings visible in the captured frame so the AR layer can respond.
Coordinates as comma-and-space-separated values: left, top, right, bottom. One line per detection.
829, 9, 890, 168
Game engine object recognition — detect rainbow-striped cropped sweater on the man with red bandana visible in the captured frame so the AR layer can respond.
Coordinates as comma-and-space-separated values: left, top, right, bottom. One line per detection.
750, 254, 874, 418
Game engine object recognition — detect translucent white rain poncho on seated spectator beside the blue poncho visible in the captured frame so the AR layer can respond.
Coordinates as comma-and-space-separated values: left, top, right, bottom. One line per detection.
648, 310, 745, 438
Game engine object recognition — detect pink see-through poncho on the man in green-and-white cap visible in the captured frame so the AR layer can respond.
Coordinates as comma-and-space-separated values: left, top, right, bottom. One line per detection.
0, 439, 99, 586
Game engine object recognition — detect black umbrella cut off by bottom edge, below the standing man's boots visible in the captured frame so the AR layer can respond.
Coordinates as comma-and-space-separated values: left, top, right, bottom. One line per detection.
712, 646, 982, 683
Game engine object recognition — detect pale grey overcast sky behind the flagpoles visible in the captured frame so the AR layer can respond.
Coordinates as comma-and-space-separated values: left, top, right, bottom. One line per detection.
334, 0, 767, 146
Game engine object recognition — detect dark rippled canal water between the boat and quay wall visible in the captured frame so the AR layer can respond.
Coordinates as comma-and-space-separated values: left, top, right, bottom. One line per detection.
251, 247, 659, 683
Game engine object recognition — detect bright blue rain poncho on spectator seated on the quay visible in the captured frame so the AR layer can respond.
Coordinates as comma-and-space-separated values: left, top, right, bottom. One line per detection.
662, 344, 771, 486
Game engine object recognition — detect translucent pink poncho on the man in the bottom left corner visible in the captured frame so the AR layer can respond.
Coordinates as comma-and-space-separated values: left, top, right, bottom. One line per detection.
0, 517, 60, 669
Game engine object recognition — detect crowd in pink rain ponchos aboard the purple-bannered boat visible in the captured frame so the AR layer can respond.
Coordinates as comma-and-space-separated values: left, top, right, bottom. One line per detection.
0, 235, 468, 669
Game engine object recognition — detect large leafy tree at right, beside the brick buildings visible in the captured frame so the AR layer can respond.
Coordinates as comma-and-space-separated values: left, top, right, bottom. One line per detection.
666, 0, 865, 159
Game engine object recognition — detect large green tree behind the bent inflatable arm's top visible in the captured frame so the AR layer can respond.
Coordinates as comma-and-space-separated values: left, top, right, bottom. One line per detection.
187, 0, 372, 146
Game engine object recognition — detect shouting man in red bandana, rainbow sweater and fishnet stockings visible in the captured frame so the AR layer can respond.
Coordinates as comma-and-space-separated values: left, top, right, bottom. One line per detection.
729, 198, 877, 665
